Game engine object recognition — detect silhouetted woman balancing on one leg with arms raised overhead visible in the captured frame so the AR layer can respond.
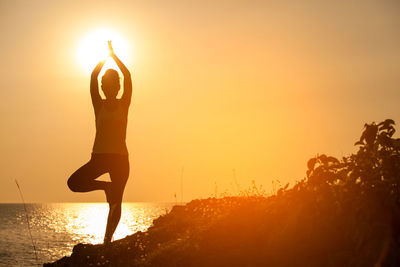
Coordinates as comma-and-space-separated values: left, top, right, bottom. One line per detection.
68, 41, 132, 244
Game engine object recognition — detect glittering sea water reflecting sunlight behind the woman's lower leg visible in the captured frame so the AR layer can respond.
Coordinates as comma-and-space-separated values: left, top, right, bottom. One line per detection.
0, 203, 173, 266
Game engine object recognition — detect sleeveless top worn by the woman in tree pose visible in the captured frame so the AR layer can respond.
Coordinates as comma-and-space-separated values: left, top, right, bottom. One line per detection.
92, 101, 128, 155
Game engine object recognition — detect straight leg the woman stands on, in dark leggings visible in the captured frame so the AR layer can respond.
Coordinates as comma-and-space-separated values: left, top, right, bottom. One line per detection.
104, 155, 129, 244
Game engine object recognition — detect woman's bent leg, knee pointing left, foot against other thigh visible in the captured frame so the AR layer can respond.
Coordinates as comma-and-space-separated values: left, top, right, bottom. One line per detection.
68, 157, 110, 192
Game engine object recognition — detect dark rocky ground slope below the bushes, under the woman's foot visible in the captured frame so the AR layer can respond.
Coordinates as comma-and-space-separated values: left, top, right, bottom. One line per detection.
43, 193, 400, 267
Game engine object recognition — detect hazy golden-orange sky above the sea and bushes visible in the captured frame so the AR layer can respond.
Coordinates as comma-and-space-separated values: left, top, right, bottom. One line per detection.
0, 0, 400, 202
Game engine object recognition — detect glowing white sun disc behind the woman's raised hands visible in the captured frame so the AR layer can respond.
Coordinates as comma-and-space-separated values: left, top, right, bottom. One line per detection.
77, 29, 130, 73
